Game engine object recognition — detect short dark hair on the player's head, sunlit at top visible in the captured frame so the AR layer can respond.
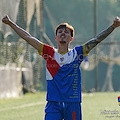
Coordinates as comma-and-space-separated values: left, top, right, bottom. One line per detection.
55, 23, 74, 37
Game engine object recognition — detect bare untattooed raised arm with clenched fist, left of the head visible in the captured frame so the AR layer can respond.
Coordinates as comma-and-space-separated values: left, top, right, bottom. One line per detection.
2, 15, 41, 51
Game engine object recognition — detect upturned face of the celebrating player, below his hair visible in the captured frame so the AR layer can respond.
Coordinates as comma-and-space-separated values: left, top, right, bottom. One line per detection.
55, 28, 73, 44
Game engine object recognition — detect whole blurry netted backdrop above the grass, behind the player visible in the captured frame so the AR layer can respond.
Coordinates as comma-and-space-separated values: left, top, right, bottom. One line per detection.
0, 0, 120, 98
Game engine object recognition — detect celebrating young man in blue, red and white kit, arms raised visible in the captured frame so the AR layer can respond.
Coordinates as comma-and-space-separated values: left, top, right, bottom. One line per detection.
2, 16, 120, 120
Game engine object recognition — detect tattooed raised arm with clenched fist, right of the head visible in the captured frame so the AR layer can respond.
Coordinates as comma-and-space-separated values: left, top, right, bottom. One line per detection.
85, 17, 120, 54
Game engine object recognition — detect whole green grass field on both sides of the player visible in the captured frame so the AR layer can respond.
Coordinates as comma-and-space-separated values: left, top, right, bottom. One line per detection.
0, 92, 120, 120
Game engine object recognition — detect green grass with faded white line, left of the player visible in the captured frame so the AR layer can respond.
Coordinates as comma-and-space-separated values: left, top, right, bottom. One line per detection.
0, 92, 46, 120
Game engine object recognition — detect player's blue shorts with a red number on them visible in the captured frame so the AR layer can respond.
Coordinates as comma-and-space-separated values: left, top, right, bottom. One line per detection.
45, 102, 82, 120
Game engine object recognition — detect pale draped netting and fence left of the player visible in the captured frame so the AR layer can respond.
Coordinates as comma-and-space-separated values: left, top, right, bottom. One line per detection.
0, 0, 46, 98
